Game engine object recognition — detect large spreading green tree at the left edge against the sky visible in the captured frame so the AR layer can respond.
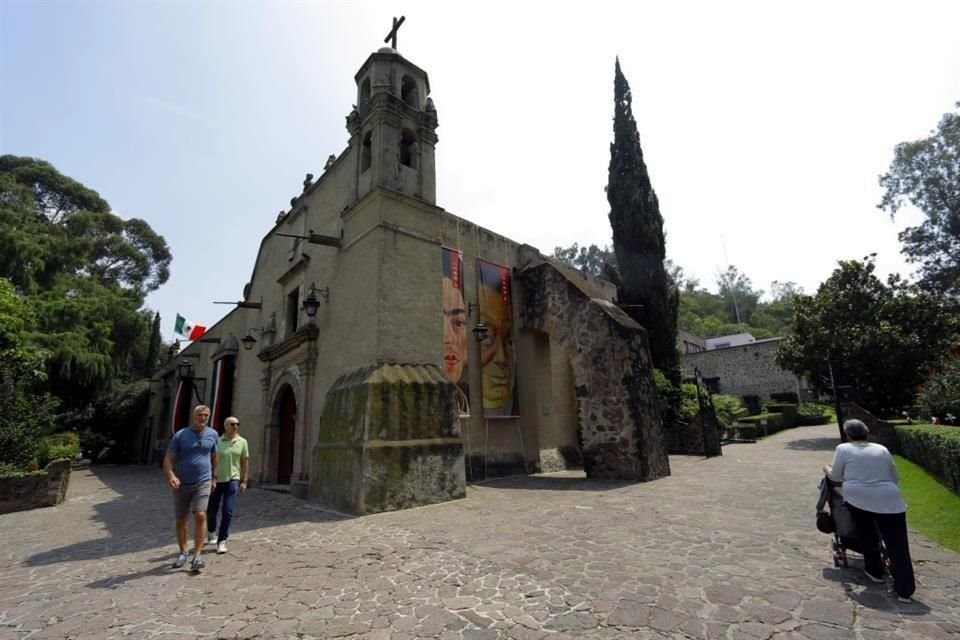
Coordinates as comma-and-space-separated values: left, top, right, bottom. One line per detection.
0, 155, 171, 410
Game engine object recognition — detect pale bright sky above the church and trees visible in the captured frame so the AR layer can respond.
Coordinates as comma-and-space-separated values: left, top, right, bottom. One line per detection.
0, 0, 960, 339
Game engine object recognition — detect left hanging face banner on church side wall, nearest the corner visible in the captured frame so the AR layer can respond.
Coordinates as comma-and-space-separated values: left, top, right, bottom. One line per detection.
441, 247, 470, 415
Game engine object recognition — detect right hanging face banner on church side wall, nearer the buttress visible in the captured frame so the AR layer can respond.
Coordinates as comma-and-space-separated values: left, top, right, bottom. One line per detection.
477, 259, 520, 418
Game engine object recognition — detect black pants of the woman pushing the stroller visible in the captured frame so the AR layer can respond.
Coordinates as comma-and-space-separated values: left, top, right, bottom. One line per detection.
847, 503, 917, 598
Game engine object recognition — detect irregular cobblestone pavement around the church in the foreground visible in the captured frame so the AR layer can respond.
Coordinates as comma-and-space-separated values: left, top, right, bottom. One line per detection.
0, 426, 960, 640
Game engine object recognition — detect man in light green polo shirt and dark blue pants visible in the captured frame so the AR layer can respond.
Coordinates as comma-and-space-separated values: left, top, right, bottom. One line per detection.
207, 416, 250, 553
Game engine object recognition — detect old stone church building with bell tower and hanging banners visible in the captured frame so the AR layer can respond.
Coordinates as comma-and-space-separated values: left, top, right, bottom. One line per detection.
141, 36, 670, 514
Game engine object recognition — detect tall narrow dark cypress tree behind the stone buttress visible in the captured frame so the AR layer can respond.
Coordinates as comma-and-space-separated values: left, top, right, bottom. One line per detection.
607, 58, 680, 388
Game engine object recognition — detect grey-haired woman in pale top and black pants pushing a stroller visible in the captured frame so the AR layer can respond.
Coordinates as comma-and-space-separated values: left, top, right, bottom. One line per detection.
823, 420, 916, 602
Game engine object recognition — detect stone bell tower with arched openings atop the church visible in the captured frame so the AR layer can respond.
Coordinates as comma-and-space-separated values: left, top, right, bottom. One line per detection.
347, 40, 437, 204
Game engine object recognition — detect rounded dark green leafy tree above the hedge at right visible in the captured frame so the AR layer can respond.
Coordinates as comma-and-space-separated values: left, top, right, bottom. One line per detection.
777, 257, 958, 415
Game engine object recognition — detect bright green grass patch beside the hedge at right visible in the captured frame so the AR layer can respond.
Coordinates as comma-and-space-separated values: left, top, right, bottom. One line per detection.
894, 456, 960, 553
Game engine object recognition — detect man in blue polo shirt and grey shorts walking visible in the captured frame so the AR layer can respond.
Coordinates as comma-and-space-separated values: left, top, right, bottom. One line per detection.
163, 404, 217, 571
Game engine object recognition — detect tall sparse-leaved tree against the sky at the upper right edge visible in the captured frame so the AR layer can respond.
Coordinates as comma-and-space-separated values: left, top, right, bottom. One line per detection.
878, 102, 960, 304
